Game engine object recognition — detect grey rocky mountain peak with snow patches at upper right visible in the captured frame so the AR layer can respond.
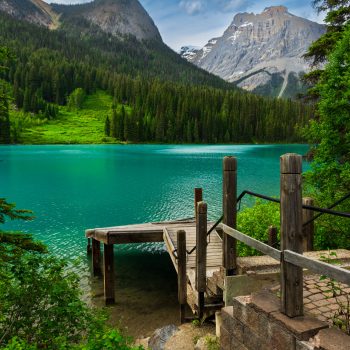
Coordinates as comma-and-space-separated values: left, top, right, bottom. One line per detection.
184, 6, 325, 96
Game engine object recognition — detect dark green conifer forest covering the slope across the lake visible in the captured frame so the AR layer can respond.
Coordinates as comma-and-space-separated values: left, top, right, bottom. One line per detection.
0, 14, 313, 143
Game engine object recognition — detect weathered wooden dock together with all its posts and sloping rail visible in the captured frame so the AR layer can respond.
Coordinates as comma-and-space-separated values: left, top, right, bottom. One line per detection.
86, 154, 350, 328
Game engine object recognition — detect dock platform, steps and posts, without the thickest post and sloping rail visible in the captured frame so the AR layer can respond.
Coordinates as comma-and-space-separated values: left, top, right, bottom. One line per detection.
85, 157, 237, 322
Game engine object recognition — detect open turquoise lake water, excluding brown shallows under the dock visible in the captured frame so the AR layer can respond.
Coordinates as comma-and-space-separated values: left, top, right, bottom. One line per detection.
0, 145, 308, 256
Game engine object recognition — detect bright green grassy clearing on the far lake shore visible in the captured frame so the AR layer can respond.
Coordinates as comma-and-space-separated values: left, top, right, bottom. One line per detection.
14, 91, 130, 144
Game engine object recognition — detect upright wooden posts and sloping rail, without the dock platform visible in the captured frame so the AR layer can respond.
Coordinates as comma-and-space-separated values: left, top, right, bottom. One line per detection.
177, 154, 350, 317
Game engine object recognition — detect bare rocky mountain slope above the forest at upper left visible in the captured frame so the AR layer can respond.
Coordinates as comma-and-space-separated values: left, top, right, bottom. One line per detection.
0, 0, 162, 41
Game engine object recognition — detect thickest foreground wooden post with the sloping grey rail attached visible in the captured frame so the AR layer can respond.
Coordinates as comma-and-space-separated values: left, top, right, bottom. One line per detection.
221, 154, 350, 317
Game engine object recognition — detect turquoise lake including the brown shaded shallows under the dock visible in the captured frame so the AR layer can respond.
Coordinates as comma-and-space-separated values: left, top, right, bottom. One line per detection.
0, 145, 308, 336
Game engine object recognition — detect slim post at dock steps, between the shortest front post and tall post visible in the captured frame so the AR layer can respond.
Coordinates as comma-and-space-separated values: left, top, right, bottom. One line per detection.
196, 202, 207, 318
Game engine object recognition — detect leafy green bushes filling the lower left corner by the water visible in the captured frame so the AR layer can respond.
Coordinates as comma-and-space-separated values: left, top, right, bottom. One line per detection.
0, 199, 142, 350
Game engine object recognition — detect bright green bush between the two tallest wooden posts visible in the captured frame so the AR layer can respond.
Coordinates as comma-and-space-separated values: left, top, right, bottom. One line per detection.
237, 200, 280, 256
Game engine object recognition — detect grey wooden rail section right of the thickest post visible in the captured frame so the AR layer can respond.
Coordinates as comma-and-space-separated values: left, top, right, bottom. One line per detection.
284, 250, 350, 286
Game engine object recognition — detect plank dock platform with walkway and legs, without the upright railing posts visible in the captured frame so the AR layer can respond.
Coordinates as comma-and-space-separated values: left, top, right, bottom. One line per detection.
86, 219, 223, 317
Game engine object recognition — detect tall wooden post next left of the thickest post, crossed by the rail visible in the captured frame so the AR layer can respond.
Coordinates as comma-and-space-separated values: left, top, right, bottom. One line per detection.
222, 157, 237, 276
